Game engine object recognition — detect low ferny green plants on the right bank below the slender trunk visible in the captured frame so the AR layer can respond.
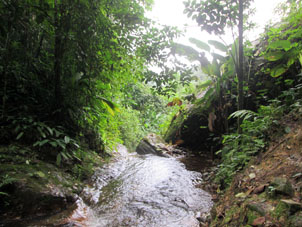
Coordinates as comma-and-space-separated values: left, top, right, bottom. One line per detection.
216, 103, 283, 185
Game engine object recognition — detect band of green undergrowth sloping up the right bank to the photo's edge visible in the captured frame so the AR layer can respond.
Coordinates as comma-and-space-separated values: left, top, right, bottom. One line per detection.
216, 75, 302, 188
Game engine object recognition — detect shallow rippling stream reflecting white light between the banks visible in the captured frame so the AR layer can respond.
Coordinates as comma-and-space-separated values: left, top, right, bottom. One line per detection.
28, 146, 213, 227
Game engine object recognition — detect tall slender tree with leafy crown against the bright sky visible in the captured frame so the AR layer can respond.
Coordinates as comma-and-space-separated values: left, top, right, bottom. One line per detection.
184, 0, 253, 132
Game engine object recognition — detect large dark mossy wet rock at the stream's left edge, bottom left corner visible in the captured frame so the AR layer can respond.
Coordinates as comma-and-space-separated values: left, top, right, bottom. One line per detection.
0, 164, 80, 226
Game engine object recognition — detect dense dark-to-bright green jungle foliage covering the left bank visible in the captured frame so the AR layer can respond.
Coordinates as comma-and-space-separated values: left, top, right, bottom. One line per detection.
0, 0, 188, 156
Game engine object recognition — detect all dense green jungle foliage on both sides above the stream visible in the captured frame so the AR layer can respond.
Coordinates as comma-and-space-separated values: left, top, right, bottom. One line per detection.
0, 0, 302, 215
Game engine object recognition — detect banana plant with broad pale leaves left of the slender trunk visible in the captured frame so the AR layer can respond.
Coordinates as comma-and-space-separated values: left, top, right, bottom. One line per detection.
172, 38, 238, 130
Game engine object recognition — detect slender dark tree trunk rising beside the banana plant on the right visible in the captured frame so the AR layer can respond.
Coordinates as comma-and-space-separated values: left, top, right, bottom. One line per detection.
237, 0, 244, 134
